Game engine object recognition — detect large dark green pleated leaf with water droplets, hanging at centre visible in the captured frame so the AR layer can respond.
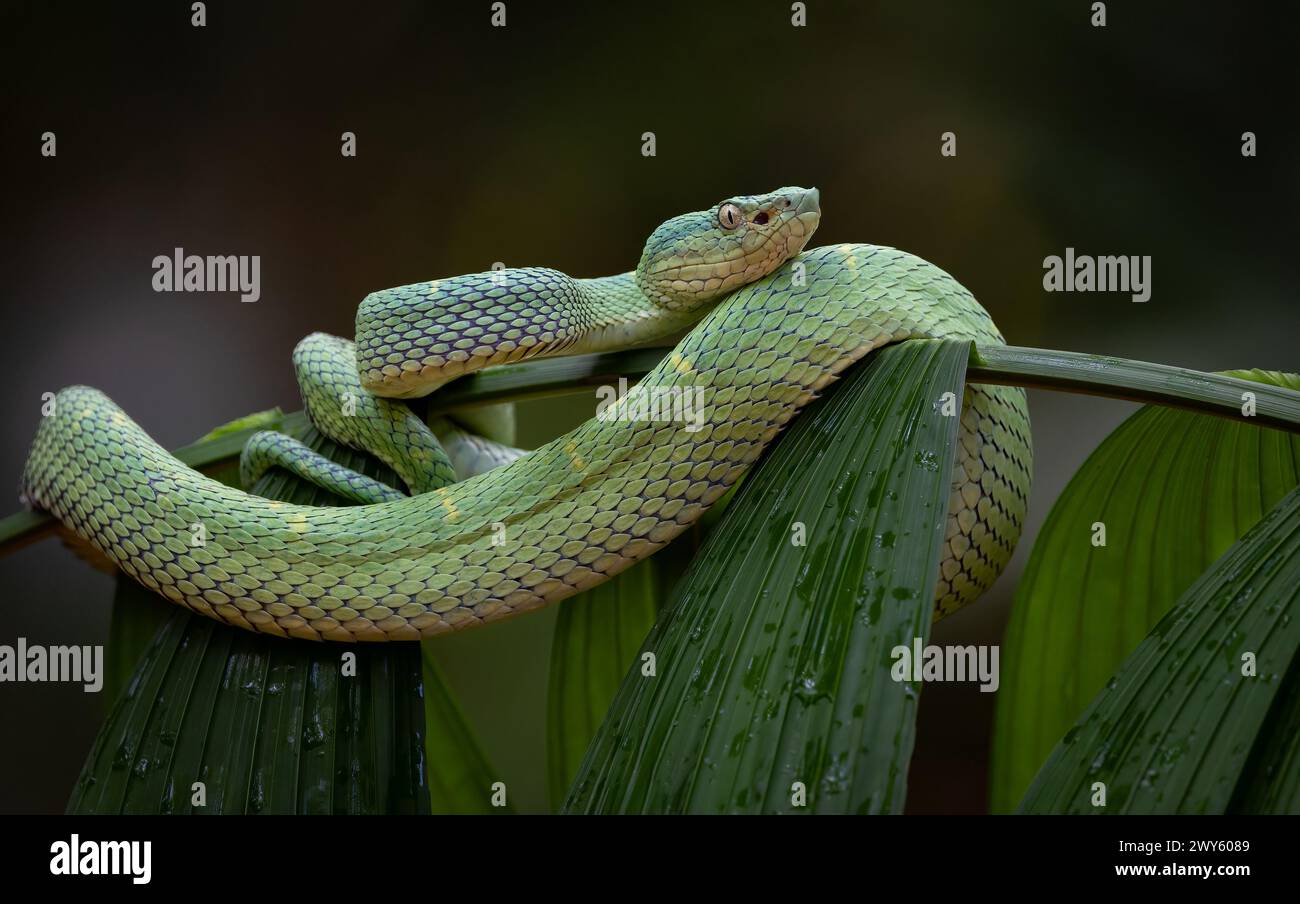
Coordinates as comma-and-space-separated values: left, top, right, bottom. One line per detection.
564, 342, 969, 813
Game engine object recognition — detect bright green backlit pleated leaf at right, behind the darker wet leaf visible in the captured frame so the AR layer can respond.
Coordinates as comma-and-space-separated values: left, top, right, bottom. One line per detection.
991, 371, 1300, 812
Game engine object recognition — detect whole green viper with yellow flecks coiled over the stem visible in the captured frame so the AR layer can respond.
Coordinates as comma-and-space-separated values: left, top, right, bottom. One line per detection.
22, 189, 1031, 641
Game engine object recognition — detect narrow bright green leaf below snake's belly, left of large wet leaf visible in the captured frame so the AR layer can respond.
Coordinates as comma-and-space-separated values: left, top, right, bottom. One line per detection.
546, 557, 659, 809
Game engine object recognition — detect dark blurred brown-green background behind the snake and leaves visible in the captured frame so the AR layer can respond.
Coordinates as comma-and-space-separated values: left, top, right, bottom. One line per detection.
0, 0, 1300, 813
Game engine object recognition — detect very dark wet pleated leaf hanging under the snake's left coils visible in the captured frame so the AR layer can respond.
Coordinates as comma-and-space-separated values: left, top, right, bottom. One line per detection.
69, 415, 491, 813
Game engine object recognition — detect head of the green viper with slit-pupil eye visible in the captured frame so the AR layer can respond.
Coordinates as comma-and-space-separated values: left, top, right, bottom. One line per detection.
636, 186, 822, 311
